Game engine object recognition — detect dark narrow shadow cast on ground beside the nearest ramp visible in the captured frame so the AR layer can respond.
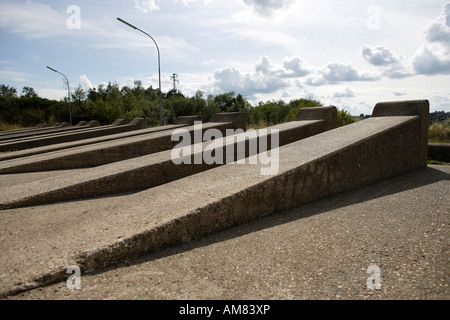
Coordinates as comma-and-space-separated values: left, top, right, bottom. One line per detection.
91, 167, 450, 275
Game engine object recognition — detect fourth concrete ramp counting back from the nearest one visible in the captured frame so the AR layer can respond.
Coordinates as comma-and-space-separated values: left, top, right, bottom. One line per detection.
0, 116, 201, 161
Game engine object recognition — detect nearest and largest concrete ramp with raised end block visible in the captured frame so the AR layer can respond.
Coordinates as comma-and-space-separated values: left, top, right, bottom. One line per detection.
0, 100, 429, 296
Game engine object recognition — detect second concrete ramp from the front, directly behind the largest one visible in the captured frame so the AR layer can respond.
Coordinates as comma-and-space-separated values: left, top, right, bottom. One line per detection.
0, 107, 337, 209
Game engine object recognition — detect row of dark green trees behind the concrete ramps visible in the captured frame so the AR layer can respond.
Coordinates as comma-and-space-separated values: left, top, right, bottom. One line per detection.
0, 81, 354, 127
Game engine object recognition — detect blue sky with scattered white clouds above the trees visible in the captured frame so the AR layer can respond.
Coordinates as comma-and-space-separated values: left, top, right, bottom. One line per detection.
0, 0, 450, 115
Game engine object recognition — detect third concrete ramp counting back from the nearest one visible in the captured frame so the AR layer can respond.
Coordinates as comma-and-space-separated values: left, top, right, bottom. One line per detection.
0, 114, 245, 174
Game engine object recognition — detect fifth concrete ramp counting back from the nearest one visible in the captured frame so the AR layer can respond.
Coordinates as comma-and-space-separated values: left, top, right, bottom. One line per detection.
0, 118, 147, 152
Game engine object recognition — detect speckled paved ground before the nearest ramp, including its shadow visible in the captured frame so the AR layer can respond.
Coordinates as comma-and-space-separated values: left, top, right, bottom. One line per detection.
8, 165, 450, 300
